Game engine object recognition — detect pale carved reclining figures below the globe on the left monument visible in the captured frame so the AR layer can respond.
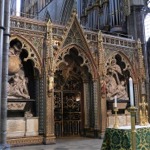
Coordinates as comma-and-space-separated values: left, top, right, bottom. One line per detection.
8, 73, 30, 99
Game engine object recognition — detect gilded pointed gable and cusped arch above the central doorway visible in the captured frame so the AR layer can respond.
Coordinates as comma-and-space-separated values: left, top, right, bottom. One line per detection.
53, 12, 97, 76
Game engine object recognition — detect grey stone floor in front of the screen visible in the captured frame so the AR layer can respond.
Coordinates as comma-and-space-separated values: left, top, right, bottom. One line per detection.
11, 137, 102, 150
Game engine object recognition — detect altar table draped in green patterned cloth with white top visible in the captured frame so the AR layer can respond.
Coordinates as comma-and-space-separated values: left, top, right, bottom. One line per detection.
101, 125, 150, 150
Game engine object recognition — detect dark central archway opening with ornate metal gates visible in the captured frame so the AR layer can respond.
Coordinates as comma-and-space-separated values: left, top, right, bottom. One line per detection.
54, 48, 91, 137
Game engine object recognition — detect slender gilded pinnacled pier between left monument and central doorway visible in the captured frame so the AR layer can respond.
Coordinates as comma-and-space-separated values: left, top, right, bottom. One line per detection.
44, 20, 55, 144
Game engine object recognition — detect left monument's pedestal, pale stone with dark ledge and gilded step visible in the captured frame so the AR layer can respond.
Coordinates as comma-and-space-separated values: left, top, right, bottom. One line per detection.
7, 99, 43, 146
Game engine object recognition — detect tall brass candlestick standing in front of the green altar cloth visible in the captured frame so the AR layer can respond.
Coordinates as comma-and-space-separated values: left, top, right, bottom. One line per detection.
128, 106, 137, 150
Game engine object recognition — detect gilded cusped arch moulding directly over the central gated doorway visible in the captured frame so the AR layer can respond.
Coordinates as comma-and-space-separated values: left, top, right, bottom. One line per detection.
54, 44, 98, 79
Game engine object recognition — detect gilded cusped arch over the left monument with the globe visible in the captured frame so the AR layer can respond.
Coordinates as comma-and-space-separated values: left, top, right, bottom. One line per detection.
10, 35, 42, 74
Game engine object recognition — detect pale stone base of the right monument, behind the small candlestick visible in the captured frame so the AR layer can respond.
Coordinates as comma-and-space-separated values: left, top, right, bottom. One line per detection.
107, 114, 131, 127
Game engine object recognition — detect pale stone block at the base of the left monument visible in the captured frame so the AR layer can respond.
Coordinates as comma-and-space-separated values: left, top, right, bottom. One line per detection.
7, 117, 39, 138
